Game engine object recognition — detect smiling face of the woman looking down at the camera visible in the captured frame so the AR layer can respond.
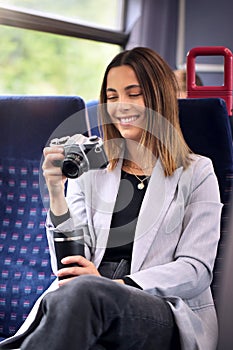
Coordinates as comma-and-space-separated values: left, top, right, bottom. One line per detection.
106, 65, 146, 142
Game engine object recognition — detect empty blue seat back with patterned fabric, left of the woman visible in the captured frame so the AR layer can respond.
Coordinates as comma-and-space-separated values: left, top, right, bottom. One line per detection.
0, 96, 87, 338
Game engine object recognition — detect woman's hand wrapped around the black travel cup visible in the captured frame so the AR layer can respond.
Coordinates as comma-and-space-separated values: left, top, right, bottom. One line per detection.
57, 255, 101, 286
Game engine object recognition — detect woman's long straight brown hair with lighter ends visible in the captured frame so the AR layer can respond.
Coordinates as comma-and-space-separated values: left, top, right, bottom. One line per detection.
100, 47, 190, 176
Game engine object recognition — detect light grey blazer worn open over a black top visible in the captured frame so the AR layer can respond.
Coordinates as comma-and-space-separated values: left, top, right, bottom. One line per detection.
0, 155, 222, 350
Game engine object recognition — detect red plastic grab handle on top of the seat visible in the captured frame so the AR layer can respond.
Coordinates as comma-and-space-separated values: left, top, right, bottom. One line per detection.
187, 46, 233, 115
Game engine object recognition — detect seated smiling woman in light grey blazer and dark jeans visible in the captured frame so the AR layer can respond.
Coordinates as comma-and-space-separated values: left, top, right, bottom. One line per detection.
0, 47, 222, 350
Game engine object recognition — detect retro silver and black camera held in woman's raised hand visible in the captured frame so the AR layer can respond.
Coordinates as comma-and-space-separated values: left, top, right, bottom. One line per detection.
51, 136, 108, 179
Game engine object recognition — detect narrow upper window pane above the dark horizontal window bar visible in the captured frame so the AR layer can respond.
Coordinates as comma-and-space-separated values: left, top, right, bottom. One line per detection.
0, 0, 124, 30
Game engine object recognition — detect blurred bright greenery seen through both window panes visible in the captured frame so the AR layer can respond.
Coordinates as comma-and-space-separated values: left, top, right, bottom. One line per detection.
0, 0, 124, 101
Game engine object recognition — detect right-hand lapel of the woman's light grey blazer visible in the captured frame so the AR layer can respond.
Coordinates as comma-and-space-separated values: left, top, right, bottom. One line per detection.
131, 160, 183, 273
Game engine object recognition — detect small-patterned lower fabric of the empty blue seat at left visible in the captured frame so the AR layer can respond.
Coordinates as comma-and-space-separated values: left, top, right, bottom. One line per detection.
0, 159, 54, 336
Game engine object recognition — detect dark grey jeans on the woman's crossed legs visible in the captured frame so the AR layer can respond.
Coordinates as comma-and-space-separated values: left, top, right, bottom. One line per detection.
1, 266, 179, 350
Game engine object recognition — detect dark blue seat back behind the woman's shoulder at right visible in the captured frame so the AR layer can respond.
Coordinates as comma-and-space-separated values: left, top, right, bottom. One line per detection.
179, 98, 233, 306
